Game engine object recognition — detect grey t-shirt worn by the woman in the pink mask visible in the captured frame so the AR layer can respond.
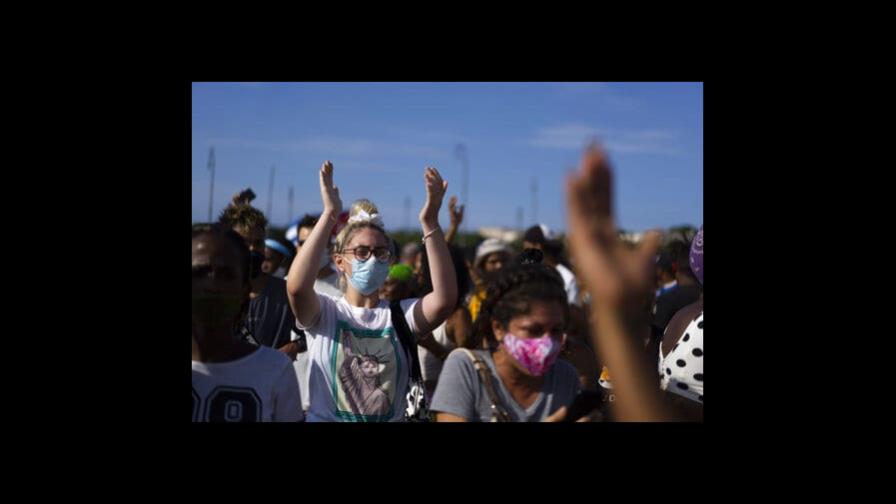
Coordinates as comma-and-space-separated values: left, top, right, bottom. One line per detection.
430, 350, 579, 422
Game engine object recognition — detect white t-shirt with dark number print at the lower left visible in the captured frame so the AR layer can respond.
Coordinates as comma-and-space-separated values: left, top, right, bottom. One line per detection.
193, 346, 304, 422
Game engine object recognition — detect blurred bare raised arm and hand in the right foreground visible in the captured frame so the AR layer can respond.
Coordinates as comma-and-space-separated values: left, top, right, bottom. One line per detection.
566, 145, 670, 421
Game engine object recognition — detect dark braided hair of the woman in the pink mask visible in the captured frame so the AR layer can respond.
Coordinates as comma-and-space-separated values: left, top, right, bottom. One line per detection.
471, 263, 569, 348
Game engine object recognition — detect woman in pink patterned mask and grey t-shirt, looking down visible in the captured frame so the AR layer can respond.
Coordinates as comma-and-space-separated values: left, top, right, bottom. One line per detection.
430, 263, 579, 422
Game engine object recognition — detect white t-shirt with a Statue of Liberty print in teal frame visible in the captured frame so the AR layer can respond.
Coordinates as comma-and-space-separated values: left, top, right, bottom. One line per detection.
296, 294, 418, 422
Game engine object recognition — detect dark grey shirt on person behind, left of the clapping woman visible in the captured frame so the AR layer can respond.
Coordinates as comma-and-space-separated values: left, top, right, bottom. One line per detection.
246, 277, 296, 349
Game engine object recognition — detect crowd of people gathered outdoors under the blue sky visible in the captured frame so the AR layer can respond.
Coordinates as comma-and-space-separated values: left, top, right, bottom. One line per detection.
192, 145, 703, 422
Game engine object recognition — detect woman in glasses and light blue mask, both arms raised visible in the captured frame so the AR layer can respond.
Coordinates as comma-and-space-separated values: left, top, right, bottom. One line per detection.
287, 161, 457, 422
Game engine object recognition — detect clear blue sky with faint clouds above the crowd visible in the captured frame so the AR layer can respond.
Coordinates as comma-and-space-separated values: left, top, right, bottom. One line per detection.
191, 82, 703, 231
